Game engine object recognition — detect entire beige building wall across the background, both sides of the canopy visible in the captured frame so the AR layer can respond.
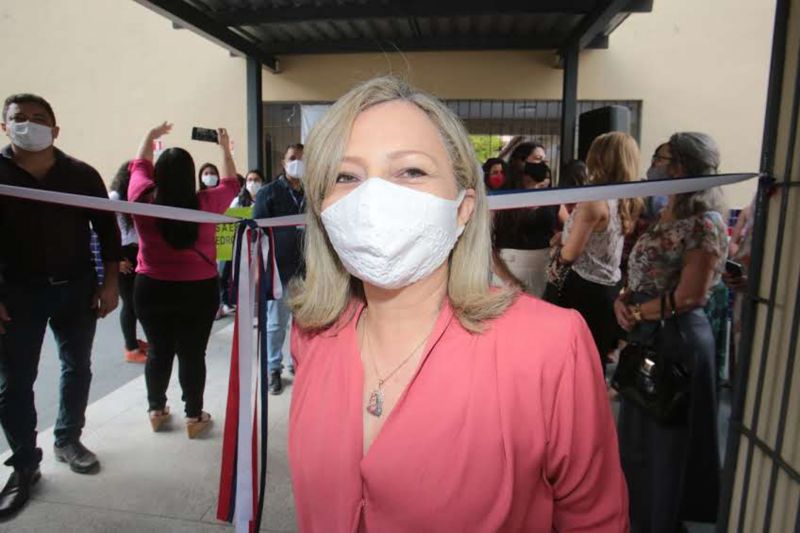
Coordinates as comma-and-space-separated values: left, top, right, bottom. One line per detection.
0, 0, 774, 205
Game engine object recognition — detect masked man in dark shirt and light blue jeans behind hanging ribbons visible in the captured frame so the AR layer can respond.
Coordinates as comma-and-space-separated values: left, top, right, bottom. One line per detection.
253, 144, 306, 394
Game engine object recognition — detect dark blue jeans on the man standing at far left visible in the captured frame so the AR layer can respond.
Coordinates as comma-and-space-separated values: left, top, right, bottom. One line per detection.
0, 273, 97, 468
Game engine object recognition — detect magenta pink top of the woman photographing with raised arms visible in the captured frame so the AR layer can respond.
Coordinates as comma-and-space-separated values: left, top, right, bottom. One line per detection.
128, 159, 239, 281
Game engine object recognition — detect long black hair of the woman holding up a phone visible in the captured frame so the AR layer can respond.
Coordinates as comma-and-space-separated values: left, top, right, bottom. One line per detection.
153, 148, 198, 250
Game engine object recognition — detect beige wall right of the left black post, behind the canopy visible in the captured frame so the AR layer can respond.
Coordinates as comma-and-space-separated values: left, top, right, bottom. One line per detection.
263, 0, 774, 206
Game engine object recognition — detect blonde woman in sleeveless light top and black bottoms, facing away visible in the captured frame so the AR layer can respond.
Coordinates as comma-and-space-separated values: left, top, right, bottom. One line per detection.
545, 132, 643, 366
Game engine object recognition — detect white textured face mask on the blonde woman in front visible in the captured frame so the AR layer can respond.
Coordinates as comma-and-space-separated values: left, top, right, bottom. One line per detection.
322, 178, 465, 289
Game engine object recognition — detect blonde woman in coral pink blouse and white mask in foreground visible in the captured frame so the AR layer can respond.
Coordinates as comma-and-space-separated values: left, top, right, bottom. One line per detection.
288, 77, 628, 533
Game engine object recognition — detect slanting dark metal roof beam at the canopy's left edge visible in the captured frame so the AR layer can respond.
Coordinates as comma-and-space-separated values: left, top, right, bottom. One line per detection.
135, 0, 279, 72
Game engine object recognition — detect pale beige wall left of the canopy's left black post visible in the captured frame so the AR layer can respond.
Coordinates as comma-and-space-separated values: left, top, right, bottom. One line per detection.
0, 0, 247, 181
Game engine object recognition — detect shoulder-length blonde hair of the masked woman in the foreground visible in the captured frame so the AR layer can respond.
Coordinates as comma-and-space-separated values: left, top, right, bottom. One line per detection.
289, 76, 518, 333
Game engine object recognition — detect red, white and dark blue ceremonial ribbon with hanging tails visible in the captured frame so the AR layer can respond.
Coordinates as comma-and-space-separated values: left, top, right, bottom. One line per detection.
0, 169, 757, 533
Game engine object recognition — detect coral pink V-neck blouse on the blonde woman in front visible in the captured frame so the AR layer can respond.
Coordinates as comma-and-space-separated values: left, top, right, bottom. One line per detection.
289, 295, 628, 533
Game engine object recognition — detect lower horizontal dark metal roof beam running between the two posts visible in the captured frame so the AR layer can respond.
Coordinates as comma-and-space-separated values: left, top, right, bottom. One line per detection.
267, 35, 580, 55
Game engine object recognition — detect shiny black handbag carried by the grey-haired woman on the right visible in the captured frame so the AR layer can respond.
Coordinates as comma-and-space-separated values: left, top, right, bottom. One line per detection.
611, 293, 692, 425
